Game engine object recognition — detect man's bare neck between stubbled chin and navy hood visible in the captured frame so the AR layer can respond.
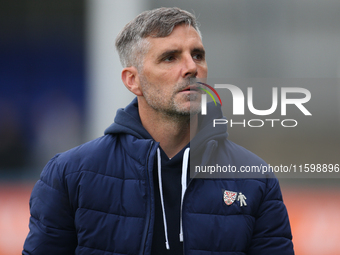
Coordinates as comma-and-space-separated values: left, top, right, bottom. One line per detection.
139, 101, 198, 158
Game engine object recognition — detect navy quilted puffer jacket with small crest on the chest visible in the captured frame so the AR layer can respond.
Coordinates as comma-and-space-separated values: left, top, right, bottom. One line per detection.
23, 100, 294, 255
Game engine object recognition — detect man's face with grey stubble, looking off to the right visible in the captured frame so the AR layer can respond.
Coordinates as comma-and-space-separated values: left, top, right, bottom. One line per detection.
140, 25, 208, 115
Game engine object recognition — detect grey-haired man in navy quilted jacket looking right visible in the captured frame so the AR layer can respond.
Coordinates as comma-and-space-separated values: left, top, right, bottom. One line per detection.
23, 8, 294, 254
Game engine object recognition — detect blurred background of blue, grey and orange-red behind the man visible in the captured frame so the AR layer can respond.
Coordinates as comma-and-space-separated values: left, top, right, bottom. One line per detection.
0, 0, 340, 255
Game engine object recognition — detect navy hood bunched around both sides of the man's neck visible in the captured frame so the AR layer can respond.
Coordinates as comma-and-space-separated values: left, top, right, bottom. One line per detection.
105, 97, 228, 147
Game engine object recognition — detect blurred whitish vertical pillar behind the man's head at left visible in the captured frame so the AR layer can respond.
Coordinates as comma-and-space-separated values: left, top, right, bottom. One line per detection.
85, 0, 148, 140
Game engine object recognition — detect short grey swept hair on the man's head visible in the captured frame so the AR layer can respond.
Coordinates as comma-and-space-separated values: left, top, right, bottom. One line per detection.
116, 7, 201, 69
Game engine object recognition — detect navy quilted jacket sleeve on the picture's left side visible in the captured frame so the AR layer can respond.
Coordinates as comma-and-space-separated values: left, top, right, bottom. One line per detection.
22, 155, 77, 255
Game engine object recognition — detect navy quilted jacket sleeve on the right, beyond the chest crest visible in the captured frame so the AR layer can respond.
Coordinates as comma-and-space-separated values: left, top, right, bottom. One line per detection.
248, 178, 294, 255
